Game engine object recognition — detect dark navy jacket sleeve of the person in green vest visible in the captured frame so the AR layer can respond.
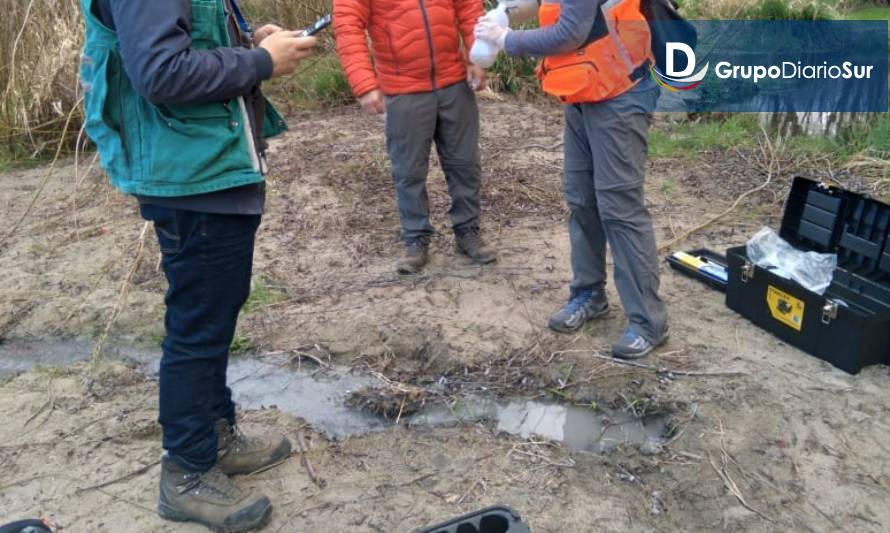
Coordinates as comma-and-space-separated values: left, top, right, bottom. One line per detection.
108, 0, 272, 104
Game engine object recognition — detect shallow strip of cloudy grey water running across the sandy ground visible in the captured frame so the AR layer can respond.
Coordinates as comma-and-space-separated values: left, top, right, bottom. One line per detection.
0, 339, 666, 453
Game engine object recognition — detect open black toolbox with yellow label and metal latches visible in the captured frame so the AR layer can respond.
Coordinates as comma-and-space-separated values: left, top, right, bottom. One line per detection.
726, 177, 890, 374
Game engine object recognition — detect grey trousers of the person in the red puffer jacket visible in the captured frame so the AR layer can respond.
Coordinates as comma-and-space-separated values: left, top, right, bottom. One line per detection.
386, 82, 482, 241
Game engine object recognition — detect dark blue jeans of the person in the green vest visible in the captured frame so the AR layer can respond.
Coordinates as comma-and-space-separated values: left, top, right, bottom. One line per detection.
141, 204, 261, 471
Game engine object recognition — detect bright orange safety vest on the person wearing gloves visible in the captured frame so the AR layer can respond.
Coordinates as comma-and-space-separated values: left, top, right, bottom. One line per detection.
538, 0, 653, 104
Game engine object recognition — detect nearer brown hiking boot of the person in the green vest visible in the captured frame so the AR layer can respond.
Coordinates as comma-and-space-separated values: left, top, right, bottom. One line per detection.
158, 457, 272, 533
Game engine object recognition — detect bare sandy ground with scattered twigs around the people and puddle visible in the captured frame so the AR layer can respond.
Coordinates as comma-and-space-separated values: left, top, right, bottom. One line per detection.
0, 97, 890, 532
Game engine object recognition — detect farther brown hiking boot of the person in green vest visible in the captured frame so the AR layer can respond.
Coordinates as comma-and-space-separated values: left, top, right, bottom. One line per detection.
215, 420, 290, 476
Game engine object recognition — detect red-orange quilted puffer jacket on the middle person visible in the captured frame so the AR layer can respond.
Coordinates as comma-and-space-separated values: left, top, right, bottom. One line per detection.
334, 0, 482, 96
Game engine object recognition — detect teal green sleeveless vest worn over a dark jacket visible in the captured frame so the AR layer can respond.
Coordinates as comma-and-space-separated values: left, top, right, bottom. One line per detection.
80, 0, 286, 196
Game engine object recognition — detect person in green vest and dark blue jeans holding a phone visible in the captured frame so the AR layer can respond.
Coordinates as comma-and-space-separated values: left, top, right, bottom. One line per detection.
81, 0, 317, 532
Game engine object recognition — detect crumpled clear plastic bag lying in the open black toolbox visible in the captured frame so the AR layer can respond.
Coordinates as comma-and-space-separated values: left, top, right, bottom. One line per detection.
748, 228, 837, 295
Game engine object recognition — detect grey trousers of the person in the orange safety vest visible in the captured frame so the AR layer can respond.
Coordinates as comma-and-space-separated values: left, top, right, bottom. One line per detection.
565, 94, 667, 342
